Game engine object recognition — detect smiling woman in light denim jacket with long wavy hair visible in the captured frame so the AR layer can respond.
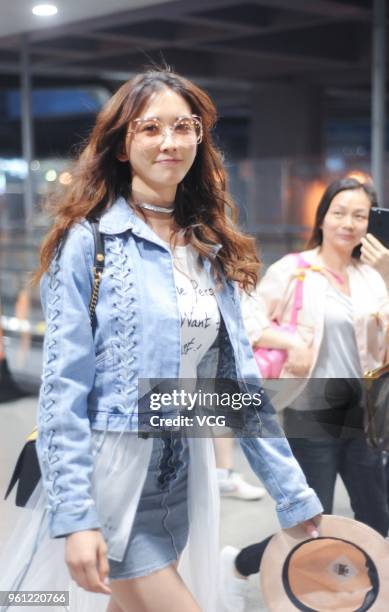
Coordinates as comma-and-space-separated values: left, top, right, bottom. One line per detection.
0, 70, 321, 612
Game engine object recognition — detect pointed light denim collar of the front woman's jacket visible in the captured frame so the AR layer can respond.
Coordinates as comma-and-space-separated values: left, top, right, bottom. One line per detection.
99, 197, 222, 258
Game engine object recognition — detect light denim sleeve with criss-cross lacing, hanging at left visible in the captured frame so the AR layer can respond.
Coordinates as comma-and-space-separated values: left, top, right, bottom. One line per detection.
37, 225, 100, 537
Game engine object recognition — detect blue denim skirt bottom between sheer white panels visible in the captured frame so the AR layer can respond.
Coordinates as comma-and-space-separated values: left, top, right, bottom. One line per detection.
109, 437, 189, 580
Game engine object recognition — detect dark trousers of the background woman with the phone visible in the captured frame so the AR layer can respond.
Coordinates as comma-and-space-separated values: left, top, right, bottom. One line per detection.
235, 405, 389, 576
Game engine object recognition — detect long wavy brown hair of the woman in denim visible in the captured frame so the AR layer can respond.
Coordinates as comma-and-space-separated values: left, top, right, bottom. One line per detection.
33, 69, 259, 291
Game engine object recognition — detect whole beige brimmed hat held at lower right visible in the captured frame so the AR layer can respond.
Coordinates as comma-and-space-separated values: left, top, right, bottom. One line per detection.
260, 515, 389, 612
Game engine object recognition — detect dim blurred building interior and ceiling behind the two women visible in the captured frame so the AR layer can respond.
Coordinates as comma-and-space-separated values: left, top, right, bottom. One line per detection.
0, 0, 389, 387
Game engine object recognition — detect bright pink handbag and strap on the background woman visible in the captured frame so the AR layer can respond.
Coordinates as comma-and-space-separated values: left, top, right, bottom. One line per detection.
254, 253, 311, 378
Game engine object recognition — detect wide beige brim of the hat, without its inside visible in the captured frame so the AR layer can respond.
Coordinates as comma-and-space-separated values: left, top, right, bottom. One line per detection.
260, 515, 389, 612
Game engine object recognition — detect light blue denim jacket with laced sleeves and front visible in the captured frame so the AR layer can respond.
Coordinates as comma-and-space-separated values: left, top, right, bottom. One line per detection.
37, 198, 322, 537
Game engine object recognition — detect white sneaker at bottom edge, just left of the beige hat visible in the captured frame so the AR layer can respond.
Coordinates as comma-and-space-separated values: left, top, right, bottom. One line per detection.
219, 546, 247, 612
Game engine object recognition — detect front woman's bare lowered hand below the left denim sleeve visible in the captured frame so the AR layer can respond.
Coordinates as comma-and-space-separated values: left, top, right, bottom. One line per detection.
65, 530, 111, 595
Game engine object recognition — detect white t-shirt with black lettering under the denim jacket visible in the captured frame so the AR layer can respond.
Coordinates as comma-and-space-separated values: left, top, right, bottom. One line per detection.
173, 245, 220, 378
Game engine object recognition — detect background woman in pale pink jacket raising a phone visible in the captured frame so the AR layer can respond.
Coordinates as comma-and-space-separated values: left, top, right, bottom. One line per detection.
221, 178, 389, 612
